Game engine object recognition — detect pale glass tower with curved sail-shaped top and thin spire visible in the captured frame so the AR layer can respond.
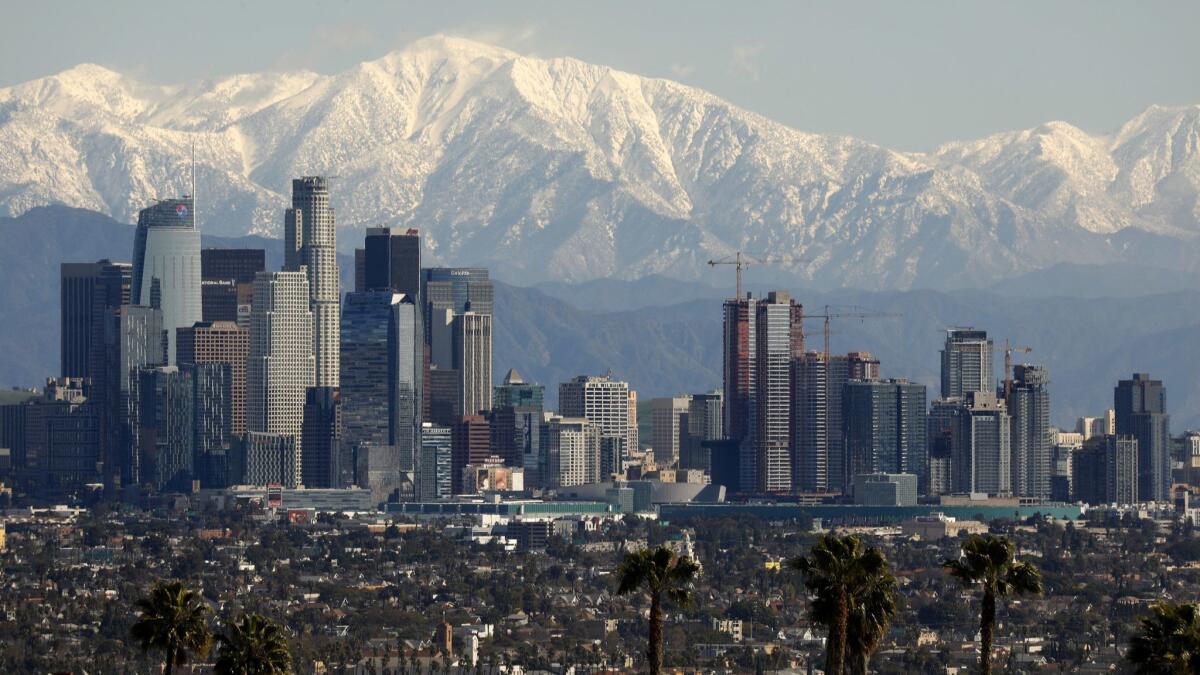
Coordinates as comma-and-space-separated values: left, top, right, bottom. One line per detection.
130, 197, 204, 365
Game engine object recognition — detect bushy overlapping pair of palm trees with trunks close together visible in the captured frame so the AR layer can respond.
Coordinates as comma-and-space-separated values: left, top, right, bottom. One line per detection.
788, 532, 896, 675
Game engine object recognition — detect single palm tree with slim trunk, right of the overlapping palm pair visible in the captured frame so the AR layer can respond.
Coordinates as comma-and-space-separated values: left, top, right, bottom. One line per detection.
942, 534, 1042, 675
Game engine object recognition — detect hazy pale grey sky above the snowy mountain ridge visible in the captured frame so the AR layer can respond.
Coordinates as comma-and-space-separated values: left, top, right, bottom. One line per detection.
0, 0, 1200, 150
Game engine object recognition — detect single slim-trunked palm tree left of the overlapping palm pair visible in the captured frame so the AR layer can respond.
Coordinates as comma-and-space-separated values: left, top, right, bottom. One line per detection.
617, 546, 700, 675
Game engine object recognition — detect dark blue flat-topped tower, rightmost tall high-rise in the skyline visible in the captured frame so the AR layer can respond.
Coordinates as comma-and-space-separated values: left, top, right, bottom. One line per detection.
1112, 372, 1171, 502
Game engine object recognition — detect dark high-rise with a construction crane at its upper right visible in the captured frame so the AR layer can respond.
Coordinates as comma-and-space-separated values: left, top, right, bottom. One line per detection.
1008, 364, 1054, 498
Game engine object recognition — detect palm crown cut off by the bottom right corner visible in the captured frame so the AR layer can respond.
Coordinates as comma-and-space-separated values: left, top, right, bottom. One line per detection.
1126, 603, 1200, 674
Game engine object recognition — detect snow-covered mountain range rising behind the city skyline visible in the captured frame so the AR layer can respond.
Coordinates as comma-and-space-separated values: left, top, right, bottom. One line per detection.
0, 36, 1200, 288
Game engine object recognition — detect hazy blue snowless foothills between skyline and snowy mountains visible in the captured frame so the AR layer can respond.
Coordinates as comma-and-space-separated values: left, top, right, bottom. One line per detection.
0, 207, 1200, 431
